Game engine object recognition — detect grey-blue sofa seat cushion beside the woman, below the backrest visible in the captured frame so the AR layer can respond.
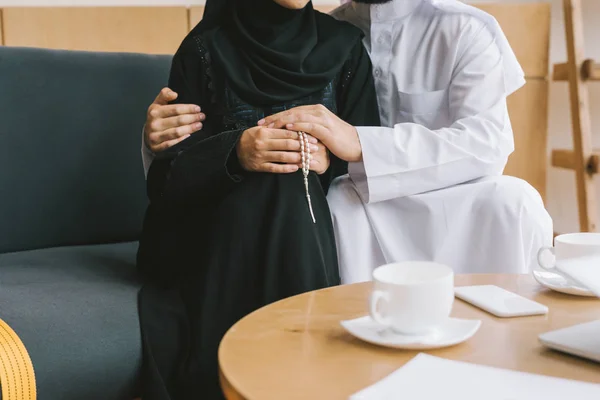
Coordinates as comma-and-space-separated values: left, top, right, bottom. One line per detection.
0, 243, 141, 400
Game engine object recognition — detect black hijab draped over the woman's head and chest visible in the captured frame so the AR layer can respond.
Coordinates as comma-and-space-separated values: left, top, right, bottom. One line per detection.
200, 0, 362, 105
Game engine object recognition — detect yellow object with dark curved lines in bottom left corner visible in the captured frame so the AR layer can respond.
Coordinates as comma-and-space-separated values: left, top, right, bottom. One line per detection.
0, 319, 37, 400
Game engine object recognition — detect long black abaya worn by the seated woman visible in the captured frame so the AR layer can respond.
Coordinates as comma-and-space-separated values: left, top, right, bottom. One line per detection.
138, 3, 379, 400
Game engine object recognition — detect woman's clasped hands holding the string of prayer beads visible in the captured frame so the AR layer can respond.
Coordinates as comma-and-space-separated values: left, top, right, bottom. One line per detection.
236, 126, 320, 174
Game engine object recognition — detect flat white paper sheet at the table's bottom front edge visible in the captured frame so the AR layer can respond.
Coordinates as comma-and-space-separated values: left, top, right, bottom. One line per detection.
350, 353, 600, 400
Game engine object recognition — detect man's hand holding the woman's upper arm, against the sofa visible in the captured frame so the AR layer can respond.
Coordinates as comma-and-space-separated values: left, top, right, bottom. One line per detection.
144, 88, 206, 153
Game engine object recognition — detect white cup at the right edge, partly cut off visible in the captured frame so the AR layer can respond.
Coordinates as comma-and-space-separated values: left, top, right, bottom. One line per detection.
538, 233, 600, 274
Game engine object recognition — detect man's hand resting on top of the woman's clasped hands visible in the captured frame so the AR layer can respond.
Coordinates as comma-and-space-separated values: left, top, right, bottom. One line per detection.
258, 104, 362, 162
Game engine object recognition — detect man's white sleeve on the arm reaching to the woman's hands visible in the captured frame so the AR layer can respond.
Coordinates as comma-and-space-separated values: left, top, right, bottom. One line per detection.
349, 26, 514, 203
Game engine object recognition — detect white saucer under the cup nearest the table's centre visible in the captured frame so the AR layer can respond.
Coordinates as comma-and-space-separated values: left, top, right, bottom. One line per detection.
341, 316, 481, 350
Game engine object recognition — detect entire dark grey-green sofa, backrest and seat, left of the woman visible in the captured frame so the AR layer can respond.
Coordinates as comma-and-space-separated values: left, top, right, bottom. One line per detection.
0, 46, 171, 400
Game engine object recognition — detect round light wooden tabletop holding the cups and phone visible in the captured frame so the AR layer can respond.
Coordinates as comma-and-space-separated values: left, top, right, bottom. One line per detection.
219, 275, 600, 400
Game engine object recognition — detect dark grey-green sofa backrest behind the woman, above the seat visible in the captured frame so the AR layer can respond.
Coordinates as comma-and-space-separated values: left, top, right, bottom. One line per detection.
0, 46, 171, 253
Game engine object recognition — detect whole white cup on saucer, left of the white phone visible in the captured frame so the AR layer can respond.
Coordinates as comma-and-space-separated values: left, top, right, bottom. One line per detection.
369, 261, 454, 335
